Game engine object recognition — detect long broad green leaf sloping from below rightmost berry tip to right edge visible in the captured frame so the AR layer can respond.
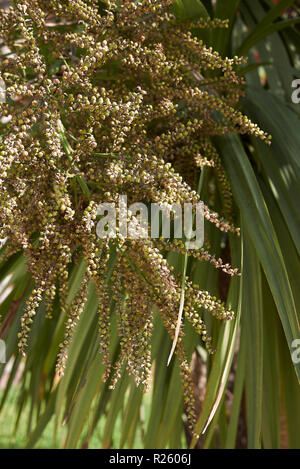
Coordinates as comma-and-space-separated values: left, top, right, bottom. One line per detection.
220, 136, 300, 380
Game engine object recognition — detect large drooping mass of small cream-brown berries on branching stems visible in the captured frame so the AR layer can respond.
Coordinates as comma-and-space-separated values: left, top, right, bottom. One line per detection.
0, 0, 269, 434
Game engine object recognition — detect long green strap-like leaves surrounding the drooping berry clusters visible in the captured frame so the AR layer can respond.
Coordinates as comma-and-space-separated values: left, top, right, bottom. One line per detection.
0, 0, 300, 448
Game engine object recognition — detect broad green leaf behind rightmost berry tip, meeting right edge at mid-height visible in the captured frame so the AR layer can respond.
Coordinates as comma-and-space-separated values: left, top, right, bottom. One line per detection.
245, 88, 300, 253
